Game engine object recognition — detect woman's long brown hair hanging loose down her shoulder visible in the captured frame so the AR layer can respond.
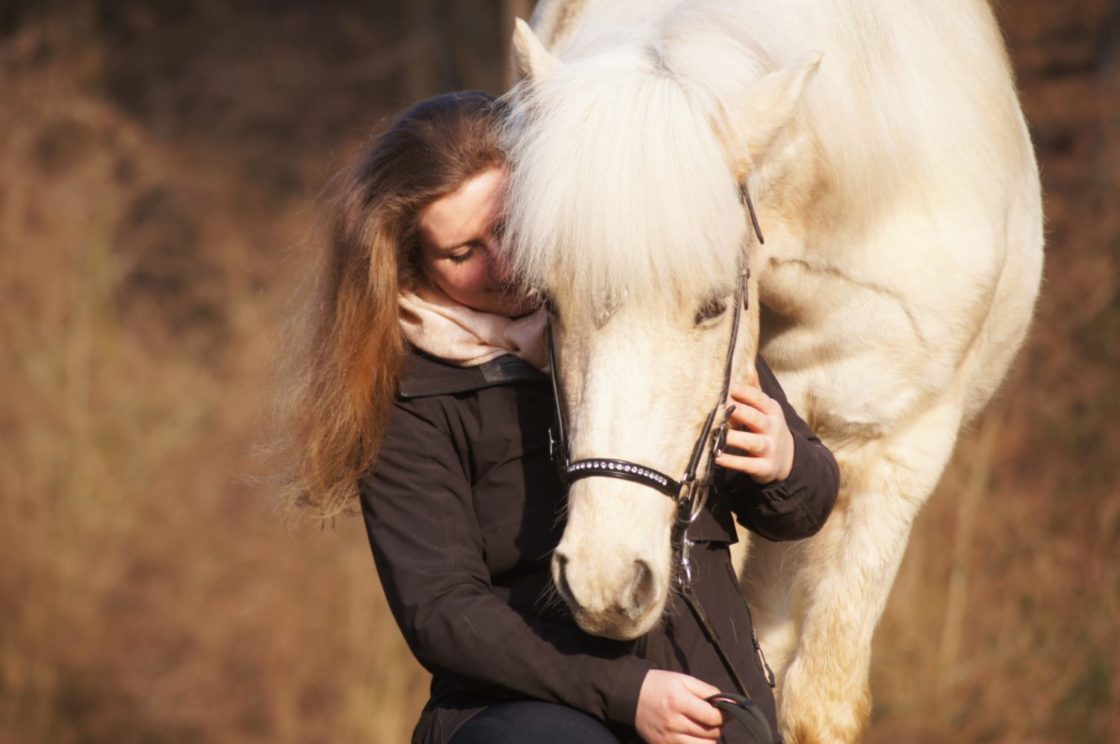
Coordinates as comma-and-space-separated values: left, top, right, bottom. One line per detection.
277, 92, 504, 517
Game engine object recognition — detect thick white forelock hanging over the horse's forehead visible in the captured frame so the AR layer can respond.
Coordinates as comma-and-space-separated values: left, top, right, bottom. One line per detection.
506, 40, 745, 310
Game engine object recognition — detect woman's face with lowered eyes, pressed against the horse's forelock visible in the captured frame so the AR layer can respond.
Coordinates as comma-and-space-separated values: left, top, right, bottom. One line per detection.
417, 167, 534, 317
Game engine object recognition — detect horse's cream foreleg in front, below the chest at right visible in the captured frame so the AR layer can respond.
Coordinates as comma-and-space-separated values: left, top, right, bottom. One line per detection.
770, 402, 961, 744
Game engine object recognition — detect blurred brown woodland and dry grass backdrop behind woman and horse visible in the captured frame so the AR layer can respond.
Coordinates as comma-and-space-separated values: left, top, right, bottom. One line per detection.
0, 0, 1120, 744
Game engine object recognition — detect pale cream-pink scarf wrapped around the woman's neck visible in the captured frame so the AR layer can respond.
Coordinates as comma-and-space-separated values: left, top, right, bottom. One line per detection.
399, 283, 549, 370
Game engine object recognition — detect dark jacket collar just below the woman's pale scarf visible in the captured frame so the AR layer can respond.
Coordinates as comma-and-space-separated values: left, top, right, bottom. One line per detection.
400, 348, 549, 400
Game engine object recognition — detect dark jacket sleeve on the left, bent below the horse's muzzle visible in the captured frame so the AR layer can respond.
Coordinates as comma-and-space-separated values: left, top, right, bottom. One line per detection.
361, 394, 652, 726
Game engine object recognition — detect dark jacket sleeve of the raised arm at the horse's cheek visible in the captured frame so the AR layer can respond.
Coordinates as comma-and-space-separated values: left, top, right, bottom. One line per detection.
717, 357, 840, 540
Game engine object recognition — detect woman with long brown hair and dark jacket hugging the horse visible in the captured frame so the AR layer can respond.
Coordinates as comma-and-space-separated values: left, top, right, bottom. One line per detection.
282, 93, 837, 744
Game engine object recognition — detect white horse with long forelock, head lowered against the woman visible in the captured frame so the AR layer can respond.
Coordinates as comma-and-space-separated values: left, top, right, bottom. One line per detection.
507, 0, 1043, 742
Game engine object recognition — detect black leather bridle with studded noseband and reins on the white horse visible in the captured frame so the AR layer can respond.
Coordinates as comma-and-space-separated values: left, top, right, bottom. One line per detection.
545, 182, 774, 744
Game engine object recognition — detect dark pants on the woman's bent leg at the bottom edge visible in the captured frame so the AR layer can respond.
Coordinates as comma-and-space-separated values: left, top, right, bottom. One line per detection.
450, 700, 618, 744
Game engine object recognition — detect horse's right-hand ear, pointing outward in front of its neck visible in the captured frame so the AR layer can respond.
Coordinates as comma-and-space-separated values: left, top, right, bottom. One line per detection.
725, 52, 822, 176
